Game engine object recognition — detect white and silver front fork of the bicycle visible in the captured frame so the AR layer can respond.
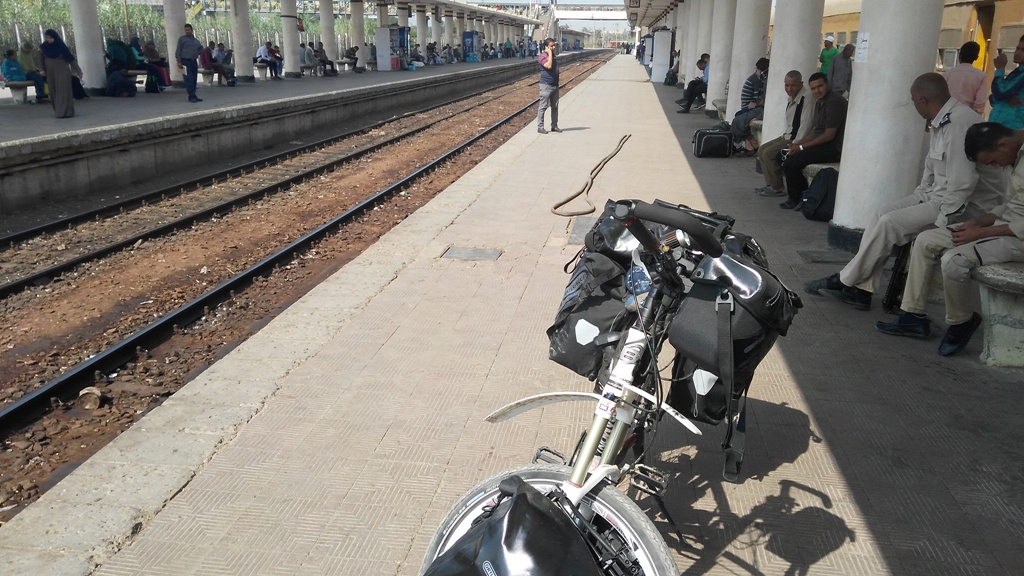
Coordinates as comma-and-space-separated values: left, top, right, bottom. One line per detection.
569, 286, 662, 488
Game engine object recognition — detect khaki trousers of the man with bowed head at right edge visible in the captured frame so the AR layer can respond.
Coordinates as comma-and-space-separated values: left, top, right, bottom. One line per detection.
900, 228, 1024, 326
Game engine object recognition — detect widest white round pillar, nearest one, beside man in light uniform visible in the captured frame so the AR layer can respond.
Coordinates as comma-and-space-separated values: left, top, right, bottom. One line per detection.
831, 0, 943, 250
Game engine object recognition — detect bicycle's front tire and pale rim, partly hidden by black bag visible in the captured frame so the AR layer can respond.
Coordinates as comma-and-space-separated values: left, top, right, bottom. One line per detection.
420, 464, 679, 576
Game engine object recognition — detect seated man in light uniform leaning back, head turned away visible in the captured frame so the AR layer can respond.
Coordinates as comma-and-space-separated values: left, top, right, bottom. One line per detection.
802, 73, 1007, 311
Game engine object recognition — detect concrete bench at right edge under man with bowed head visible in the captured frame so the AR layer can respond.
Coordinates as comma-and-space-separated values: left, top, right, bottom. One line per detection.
972, 262, 1024, 368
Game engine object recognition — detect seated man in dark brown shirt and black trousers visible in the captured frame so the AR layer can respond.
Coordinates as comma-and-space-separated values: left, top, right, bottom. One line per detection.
779, 72, 847, 206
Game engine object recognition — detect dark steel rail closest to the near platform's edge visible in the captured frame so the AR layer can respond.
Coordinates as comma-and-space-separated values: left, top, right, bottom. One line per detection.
0, 57, 606, 433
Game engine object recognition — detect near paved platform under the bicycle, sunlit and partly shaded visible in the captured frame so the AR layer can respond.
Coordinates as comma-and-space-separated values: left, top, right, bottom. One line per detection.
0, 55, 1024, 576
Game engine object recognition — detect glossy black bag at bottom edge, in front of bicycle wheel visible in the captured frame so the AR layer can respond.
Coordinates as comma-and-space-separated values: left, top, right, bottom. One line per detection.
423, 476, 603, 576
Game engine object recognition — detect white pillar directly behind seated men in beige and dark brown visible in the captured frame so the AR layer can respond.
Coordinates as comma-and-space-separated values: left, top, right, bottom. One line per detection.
762, 0, 825, 140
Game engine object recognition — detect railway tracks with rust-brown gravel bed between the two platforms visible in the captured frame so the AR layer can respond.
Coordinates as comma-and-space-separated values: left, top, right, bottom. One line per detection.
0, 55, 607, 522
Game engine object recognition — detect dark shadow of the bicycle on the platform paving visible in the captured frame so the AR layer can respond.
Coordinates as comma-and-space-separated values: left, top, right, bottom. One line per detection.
633, 399, 856, 576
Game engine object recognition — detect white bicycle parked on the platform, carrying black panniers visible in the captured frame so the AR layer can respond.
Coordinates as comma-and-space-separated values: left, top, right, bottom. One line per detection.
421, 201, 799, 576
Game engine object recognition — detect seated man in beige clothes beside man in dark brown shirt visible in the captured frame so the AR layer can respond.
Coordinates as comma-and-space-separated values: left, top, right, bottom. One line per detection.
756, 70, 815, 196
